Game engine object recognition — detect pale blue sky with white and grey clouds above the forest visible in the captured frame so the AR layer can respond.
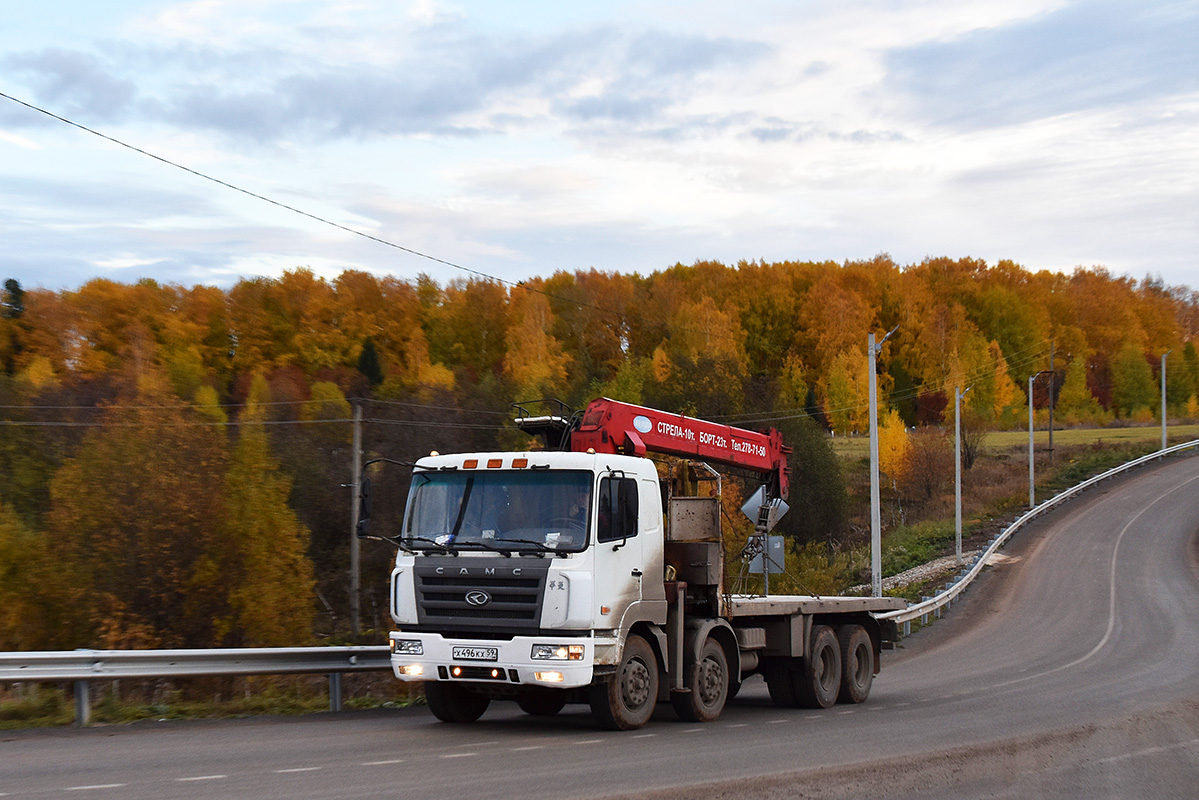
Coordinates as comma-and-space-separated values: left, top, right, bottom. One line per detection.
0, 0, 1199, 289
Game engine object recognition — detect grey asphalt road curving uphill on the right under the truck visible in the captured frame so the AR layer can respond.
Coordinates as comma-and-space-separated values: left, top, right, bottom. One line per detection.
0, 457, 1199, 800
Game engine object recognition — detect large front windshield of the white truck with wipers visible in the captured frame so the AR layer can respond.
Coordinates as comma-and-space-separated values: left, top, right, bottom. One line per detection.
403, 470, 591, 552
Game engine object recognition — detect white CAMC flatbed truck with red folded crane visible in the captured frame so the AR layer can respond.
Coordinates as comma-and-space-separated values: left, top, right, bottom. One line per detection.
359, 398, 905, 730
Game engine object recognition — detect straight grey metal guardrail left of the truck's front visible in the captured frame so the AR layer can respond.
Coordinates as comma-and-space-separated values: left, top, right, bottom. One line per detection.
0, 645, 391, 726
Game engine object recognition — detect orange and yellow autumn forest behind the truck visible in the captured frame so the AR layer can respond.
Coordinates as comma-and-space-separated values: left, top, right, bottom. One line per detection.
0, 255, 1199, 650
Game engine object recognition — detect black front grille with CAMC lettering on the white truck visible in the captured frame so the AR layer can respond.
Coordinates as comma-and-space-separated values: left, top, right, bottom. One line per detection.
415, 557, 549, 633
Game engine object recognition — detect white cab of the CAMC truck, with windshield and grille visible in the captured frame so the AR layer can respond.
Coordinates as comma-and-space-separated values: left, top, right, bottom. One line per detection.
391, 452, 667, 688
